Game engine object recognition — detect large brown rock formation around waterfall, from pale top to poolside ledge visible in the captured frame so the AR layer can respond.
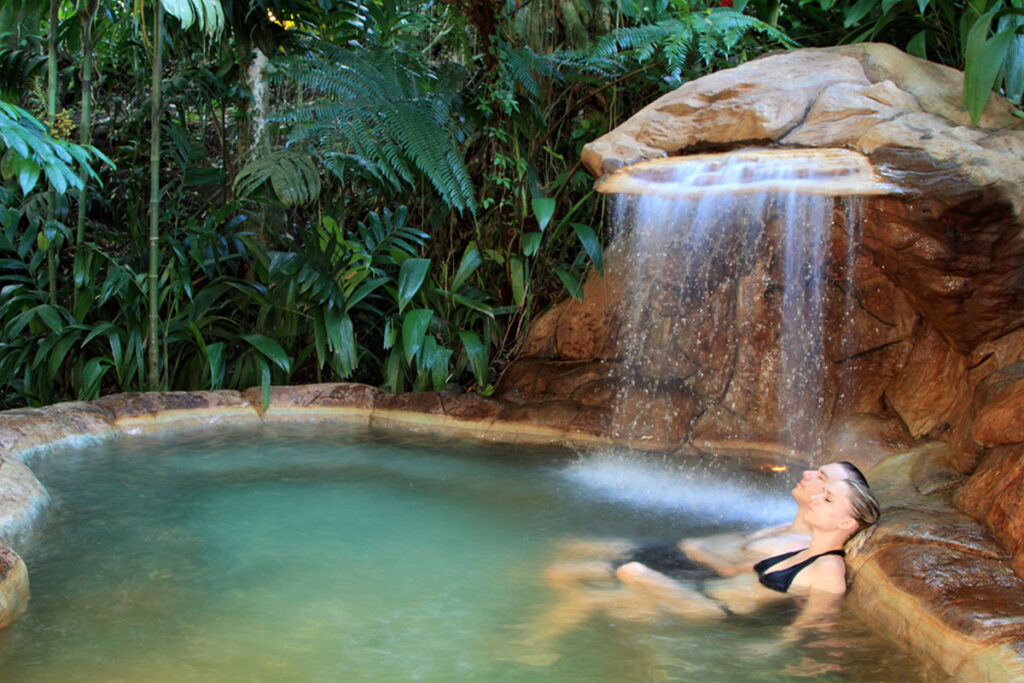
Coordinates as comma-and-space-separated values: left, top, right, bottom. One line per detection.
498, 44, 1024, 680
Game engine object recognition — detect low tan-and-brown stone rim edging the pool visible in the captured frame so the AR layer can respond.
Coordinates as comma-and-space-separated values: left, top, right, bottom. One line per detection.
0, 383, 1024, 681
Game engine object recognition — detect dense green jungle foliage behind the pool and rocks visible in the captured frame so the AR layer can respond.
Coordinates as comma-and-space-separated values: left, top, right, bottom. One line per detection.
0, 0, 1024, 409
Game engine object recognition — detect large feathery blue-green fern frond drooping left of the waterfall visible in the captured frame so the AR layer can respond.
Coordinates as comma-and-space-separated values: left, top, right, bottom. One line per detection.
272, 44, 476, 211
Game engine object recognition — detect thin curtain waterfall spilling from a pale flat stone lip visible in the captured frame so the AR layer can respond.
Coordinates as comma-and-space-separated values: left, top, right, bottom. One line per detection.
599, 150, 892, 452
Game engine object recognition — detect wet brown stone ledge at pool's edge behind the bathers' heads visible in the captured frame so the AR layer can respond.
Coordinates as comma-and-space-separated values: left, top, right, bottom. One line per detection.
848, 443, 1024, 681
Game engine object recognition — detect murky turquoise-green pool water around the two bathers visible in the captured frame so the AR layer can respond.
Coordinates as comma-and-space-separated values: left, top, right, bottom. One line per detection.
0, 425, 937, 681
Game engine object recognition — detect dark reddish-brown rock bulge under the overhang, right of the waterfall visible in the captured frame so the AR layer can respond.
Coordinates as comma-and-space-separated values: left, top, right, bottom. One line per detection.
863, 147, 1024, 354
